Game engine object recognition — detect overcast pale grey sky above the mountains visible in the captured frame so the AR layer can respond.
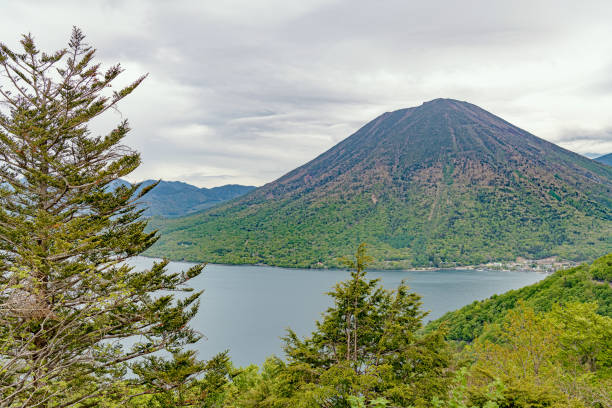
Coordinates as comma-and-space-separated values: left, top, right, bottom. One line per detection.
0, 0, 612, 187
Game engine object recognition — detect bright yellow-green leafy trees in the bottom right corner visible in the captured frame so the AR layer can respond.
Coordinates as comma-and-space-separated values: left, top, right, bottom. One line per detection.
463, 302, 612, 407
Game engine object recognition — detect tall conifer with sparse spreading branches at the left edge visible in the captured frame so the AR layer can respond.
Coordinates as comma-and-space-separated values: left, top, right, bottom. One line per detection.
0, 28, 219, 407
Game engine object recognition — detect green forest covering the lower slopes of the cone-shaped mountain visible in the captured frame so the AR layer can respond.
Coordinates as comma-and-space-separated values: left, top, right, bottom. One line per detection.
146, 187, 612, 269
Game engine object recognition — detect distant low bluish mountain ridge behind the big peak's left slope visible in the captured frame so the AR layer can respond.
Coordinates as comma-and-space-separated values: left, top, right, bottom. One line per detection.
110, 180, 255, 218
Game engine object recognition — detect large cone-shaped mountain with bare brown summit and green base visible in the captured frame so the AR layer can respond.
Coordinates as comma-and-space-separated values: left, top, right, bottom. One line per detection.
148, 99, 612, 268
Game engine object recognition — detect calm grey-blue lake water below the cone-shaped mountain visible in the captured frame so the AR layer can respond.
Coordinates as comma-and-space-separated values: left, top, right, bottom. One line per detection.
130, 257, 545, 366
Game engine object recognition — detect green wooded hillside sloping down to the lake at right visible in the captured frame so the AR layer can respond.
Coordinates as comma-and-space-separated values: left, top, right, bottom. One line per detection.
427, 253, 612, 341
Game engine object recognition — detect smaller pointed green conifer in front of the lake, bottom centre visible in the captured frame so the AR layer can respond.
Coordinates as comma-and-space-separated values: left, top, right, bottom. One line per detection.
230, 245, 451, 407
